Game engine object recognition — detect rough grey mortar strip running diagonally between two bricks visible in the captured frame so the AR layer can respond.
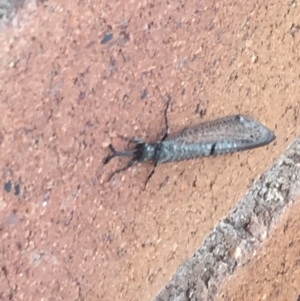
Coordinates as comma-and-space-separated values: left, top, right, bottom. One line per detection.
154, 138, 300, 301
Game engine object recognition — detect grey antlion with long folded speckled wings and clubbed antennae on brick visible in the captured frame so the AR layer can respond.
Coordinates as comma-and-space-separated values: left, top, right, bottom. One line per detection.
104, 99, 276, 182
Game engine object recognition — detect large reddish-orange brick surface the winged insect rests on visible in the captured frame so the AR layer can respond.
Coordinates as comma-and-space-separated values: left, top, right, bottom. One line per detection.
0, 0, 300, 301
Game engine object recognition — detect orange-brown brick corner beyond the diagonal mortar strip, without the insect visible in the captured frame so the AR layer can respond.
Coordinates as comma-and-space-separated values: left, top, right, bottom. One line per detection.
216, 192, 300, 301
